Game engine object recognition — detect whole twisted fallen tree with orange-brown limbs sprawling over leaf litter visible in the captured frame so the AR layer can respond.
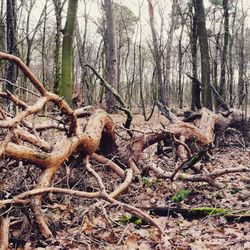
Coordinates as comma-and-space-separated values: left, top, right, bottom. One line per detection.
0, 52, 250, 249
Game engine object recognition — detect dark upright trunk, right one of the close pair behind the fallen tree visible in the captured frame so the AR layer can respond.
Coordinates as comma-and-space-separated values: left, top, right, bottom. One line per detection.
193, 0, 212, 109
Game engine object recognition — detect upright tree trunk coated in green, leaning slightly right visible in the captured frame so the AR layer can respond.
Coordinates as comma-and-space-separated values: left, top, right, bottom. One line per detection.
59, 0, 78, 106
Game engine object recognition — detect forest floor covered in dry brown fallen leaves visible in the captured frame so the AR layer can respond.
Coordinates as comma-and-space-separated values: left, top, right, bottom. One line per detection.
1, 115, 250, 250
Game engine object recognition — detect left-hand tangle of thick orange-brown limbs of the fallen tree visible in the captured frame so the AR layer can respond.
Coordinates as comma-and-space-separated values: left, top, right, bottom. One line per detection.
0, 52, 162, 242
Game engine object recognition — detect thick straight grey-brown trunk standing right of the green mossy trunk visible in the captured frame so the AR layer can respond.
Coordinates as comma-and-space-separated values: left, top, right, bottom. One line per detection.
104, 0, 117, 113
